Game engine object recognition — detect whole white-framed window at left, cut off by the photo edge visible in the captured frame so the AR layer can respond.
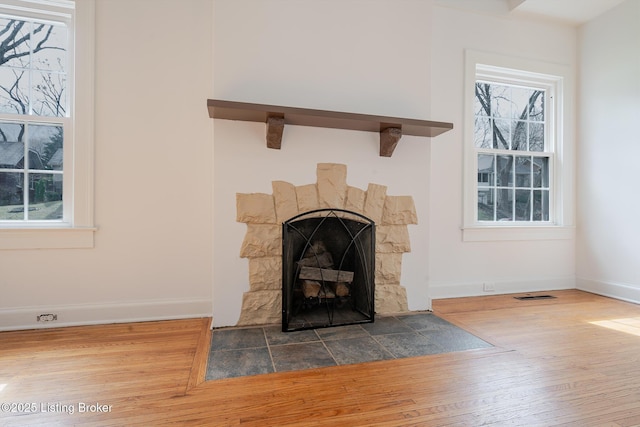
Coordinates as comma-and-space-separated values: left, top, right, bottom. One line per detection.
0, 0, 95, 249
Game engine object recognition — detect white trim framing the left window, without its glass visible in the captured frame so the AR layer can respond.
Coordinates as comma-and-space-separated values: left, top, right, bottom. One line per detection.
0, 0, 96, 249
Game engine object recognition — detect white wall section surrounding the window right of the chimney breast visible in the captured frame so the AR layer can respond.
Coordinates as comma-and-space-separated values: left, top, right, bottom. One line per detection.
429, 6, 577, 298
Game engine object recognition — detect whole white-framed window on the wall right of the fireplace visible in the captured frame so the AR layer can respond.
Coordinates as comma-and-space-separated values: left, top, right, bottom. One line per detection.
464, 52, 573, 240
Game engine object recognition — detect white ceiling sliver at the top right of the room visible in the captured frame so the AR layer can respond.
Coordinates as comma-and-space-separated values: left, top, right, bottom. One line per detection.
436, 0, 625, 25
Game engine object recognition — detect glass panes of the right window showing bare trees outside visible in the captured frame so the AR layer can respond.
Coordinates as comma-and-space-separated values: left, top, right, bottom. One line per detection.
474, 80, 551, 222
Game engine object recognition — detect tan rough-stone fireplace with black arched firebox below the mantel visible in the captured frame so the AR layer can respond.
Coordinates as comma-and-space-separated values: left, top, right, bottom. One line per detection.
236, 163, 418, 329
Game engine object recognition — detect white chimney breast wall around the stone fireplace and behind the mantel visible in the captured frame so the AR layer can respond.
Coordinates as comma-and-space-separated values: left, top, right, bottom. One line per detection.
213, 0, 438, 325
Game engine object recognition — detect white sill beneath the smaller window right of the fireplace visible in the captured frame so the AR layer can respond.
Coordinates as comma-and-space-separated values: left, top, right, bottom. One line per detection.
462, 225, 576, 242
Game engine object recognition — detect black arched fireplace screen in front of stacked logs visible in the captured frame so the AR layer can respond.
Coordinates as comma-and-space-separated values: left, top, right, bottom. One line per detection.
282, 209, 375, 332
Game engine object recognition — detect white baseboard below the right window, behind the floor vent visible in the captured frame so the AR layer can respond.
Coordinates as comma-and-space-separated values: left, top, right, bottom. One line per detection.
429, 276, 576, 300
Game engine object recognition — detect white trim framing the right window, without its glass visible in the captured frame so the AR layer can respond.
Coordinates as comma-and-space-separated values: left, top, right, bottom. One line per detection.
462, 50, 575, 242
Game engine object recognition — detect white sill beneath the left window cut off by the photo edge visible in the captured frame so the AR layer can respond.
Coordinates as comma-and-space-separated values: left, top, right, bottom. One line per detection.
0, 227, 96, 250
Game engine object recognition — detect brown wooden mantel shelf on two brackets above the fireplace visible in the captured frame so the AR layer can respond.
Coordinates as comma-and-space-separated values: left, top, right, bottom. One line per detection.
207, 99, 453, 157
